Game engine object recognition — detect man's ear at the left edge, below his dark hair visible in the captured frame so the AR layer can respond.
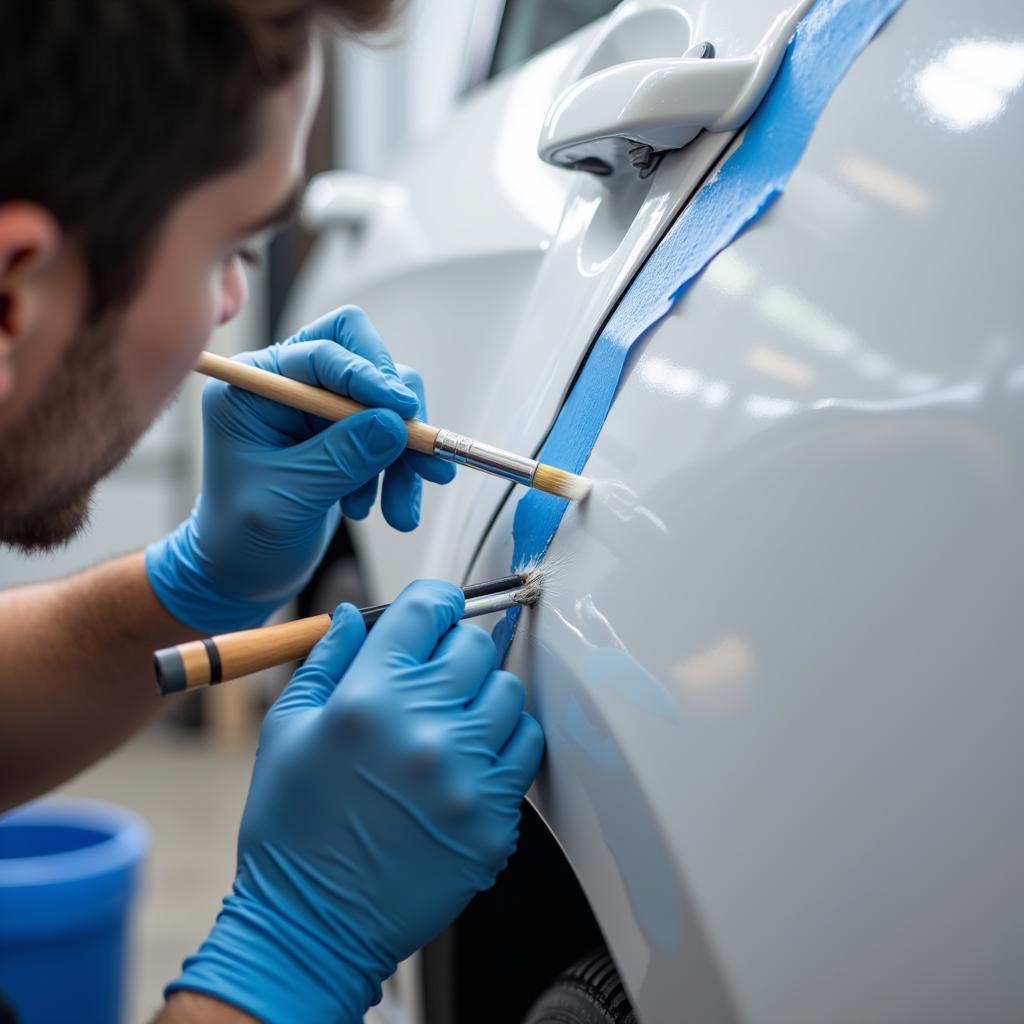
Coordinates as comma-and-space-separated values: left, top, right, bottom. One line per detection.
0, 203, 60, 399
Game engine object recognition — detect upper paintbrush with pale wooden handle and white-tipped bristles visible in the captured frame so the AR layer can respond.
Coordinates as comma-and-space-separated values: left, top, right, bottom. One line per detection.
196, 352, 591, 501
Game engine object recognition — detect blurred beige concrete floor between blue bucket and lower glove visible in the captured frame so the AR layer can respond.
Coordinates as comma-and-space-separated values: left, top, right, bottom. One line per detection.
60, 726, 255, 1024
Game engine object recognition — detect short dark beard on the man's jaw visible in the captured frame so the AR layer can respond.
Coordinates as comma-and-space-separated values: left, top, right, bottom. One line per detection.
0, 313, 145, 554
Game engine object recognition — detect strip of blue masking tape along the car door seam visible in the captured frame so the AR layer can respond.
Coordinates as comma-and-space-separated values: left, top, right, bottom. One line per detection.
494, 0, 902, 652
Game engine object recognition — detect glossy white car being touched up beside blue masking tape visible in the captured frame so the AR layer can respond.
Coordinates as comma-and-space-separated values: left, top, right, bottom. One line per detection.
285, 0, 1024, 1024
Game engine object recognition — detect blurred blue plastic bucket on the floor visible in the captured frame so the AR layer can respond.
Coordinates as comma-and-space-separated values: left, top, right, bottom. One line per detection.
0, 799, 150, 1024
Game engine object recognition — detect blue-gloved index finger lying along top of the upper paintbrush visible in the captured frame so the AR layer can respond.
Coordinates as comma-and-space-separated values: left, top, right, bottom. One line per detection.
276, 339, 420, 419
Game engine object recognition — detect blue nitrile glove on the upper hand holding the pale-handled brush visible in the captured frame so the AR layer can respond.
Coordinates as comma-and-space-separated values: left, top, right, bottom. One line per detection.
145, 306, 455, 633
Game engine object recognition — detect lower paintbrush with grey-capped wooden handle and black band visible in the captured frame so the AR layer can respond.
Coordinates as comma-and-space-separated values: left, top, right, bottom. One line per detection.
153, 572, 541, 696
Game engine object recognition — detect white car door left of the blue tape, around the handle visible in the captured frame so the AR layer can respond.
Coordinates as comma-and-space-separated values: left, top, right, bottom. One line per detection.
286, 0, 807, 599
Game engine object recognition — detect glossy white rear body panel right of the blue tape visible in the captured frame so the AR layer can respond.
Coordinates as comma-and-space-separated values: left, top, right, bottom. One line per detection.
473, 2, 1024, 1024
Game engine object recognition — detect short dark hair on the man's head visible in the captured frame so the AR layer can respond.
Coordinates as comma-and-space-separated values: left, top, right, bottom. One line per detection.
0, 0, 398, 319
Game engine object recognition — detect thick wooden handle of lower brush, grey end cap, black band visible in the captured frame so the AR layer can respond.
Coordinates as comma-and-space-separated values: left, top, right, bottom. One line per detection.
154, 615, 331, 694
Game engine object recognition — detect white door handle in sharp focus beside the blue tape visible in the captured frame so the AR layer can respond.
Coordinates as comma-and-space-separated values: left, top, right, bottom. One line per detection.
538, 0, 813, 177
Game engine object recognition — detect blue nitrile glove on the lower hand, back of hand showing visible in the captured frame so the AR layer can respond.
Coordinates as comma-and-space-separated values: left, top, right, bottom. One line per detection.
167, 581, 544, 1024
